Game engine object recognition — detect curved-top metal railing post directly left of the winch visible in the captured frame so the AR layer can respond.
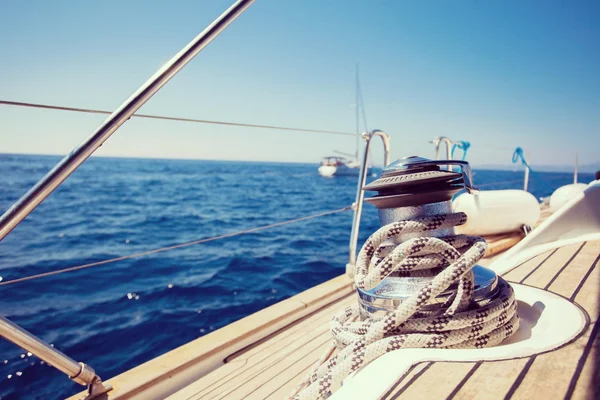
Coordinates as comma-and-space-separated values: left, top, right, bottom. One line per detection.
346, 129, 390, 277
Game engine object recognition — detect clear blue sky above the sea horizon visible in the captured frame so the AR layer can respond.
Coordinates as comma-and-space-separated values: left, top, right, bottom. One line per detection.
0, 0, 600, 165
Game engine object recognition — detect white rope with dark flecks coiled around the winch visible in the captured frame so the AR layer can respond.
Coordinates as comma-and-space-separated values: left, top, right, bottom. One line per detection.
291, 213, 519, 400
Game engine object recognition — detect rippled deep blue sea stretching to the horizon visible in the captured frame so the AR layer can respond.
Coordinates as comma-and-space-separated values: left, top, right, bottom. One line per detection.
0, 155, 593, 400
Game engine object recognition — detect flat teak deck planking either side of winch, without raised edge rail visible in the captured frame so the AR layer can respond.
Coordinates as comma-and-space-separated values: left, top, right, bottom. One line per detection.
169, 241, 600, 400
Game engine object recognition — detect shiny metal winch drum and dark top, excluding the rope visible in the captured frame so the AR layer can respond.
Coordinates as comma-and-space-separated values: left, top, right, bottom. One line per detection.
357, 156, 498, 318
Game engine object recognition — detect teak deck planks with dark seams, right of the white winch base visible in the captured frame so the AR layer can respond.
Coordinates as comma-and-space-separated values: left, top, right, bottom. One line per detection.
390, 242, 600, 399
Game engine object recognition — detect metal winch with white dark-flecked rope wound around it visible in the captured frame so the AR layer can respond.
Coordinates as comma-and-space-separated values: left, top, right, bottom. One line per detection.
294, 151, 519, 400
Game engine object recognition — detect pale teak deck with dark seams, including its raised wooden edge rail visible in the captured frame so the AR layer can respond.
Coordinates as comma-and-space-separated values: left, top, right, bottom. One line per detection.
70, 208, 600, 400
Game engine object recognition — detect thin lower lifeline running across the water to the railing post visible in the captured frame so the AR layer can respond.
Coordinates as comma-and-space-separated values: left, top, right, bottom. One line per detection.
0, 206, 352, 286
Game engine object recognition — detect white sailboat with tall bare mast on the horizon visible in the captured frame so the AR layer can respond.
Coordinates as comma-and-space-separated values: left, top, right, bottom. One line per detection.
319, 65, 371, 177
